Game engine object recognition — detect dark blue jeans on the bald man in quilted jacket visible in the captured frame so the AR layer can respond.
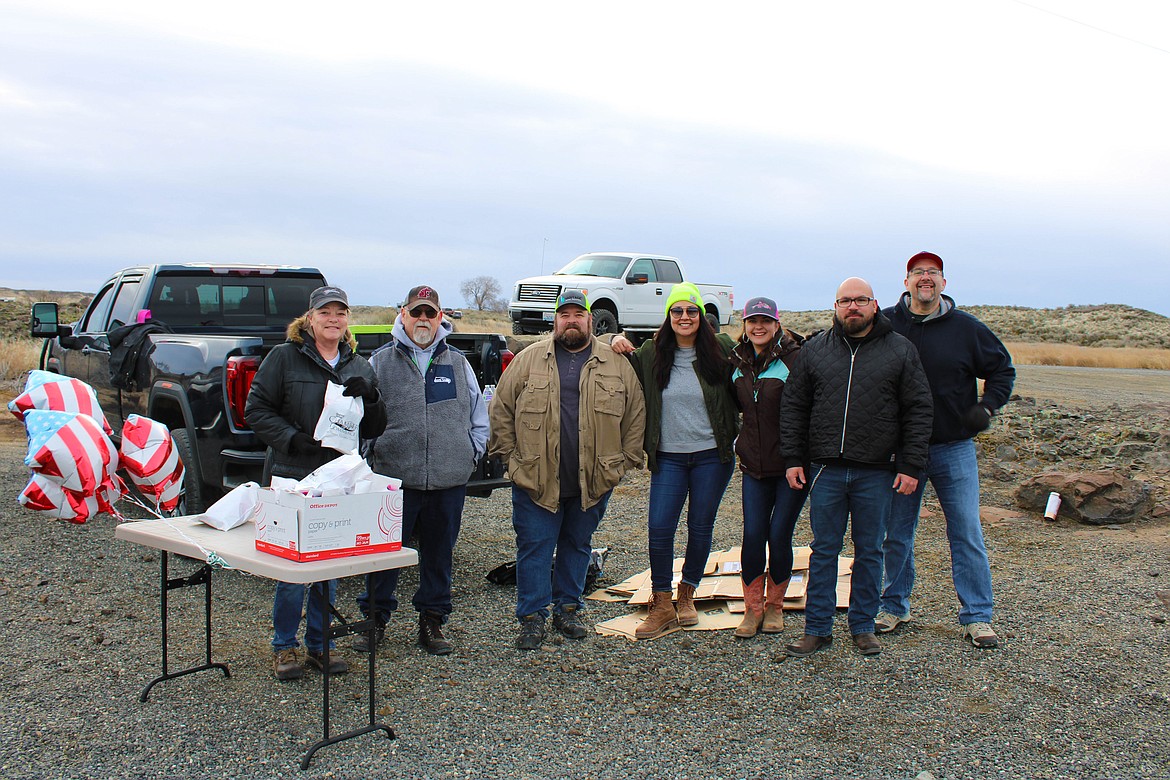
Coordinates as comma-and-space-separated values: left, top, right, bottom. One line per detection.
805, 464, 894, 636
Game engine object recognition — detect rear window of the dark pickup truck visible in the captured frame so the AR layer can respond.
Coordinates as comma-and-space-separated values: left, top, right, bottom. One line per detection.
150, 272, 323, 329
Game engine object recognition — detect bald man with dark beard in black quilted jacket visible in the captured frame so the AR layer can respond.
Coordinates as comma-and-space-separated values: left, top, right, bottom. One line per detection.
780, 277, 934, 657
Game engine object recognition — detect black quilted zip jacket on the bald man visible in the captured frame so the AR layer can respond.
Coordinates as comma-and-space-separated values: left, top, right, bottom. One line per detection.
780, 312, 934, 478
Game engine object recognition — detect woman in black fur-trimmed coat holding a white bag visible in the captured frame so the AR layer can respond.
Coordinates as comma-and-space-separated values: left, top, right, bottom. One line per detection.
245, 287, 386, 679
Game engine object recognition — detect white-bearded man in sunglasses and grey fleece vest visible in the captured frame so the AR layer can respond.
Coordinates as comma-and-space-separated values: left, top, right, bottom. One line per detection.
353, 284, 488, 655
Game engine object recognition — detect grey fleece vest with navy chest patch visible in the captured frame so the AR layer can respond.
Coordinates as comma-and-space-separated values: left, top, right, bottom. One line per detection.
370, 341, 480, 490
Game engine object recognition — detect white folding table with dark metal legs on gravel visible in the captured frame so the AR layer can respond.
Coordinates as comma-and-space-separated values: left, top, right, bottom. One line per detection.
113, 517, 419, 769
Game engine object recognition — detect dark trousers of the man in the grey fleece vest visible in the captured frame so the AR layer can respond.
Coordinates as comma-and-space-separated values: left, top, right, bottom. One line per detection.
358, 485, 467, 623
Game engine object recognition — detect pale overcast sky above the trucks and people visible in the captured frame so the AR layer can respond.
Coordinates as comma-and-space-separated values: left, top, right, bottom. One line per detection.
0, 0, 1170, 315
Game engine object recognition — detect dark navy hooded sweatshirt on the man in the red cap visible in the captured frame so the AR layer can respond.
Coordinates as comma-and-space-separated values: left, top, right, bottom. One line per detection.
885, 292, 1016, 444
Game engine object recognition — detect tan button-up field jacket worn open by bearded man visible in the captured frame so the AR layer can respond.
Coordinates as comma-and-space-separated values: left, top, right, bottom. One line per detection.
488, 337, 646, 512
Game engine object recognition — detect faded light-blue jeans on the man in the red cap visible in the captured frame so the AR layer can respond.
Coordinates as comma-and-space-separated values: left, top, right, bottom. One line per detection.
881, 439, 995, 626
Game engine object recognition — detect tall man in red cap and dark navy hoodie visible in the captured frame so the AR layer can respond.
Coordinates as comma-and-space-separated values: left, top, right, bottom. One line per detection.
875, 251, 1016, 648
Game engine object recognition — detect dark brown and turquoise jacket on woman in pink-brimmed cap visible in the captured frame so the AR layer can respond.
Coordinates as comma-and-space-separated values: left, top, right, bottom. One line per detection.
731, 330, 804, 479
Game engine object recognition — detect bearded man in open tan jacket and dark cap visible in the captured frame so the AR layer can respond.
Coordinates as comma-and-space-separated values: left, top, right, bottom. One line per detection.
488, 290, 646, 650
